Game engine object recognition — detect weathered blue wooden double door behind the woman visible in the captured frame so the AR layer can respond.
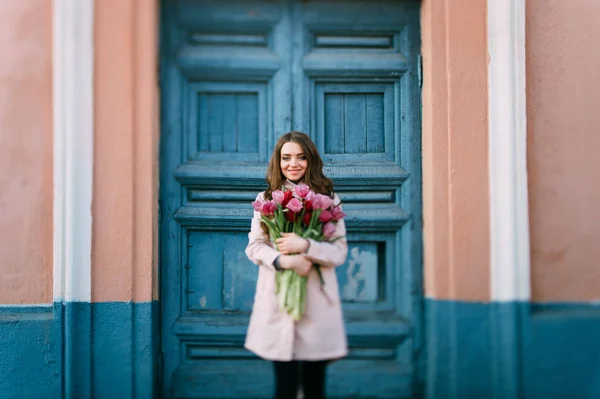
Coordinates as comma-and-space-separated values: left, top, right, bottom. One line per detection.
160, 0, 422, 398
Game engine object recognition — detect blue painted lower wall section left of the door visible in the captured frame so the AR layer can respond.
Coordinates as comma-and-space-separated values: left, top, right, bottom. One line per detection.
0, 302, 159, 399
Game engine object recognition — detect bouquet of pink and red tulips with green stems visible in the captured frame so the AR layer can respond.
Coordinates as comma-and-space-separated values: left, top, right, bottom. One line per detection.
252, 184, 345, 320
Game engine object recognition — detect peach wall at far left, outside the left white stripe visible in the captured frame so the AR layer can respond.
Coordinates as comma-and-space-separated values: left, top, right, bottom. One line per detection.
0, 0, 53, 304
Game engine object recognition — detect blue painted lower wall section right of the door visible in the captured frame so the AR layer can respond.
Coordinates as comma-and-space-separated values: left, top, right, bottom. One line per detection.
425, 299, 600, 399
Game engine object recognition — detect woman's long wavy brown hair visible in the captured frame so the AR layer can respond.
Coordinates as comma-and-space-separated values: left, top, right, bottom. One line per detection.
265, 131, 333, 200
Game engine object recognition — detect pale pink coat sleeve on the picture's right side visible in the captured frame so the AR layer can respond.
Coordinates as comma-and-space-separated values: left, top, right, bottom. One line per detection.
305, 195, 348, 267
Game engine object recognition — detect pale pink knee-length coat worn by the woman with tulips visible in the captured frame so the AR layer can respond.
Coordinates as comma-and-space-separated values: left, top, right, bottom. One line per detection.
244, 181, 348, 361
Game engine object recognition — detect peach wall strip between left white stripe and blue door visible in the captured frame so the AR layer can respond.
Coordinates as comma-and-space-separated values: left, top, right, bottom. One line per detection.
92, 0, 158, 302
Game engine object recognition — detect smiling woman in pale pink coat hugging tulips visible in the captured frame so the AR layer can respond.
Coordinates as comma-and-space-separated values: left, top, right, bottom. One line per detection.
245, 132, 348, 399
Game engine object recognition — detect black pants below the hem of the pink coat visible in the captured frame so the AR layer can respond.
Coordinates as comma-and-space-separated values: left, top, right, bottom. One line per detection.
273, 360, 327, 399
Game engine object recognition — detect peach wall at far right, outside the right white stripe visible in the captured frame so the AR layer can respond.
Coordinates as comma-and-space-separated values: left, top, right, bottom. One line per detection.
526, 0, 600, 302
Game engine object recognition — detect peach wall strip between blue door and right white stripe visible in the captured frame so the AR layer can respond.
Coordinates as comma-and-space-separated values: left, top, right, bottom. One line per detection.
421, 0, 490, 301
